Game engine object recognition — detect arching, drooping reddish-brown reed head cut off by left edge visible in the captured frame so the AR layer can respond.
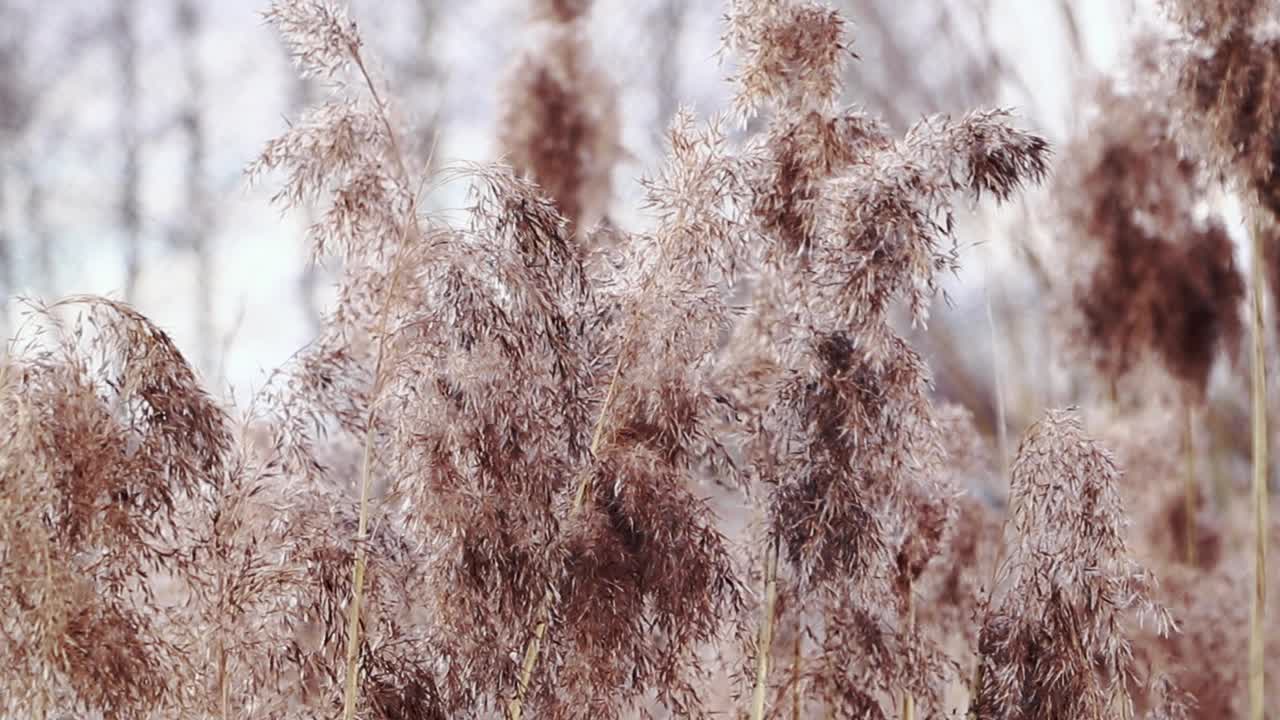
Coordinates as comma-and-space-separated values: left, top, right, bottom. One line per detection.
0, 297, 232, 719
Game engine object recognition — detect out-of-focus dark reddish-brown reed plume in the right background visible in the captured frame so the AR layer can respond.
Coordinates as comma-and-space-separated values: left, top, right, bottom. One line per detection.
1056, 86, 1244, 404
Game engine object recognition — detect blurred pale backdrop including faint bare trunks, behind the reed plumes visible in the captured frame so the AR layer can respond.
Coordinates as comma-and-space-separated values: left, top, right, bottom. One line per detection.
0, 0, 1158, 420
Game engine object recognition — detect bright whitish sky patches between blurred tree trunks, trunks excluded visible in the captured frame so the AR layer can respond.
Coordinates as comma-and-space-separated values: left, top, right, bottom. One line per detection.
0, 0, 1157, 393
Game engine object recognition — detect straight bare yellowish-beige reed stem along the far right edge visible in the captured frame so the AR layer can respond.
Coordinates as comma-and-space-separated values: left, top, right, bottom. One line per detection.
1249, 208, 1268, 720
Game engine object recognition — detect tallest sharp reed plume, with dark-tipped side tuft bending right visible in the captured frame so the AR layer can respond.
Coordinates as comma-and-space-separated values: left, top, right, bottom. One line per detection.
726, 0, 1047, 717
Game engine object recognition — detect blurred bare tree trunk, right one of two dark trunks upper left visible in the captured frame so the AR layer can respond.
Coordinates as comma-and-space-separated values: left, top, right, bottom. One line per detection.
177, 0, 218, 372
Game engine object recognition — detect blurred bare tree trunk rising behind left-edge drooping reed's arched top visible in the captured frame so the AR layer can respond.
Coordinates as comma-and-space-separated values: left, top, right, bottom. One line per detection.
113, 0, 142, 302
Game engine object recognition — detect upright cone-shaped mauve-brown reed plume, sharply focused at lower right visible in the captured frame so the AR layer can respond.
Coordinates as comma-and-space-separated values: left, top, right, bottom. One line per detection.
973, 410, 1172, 720
